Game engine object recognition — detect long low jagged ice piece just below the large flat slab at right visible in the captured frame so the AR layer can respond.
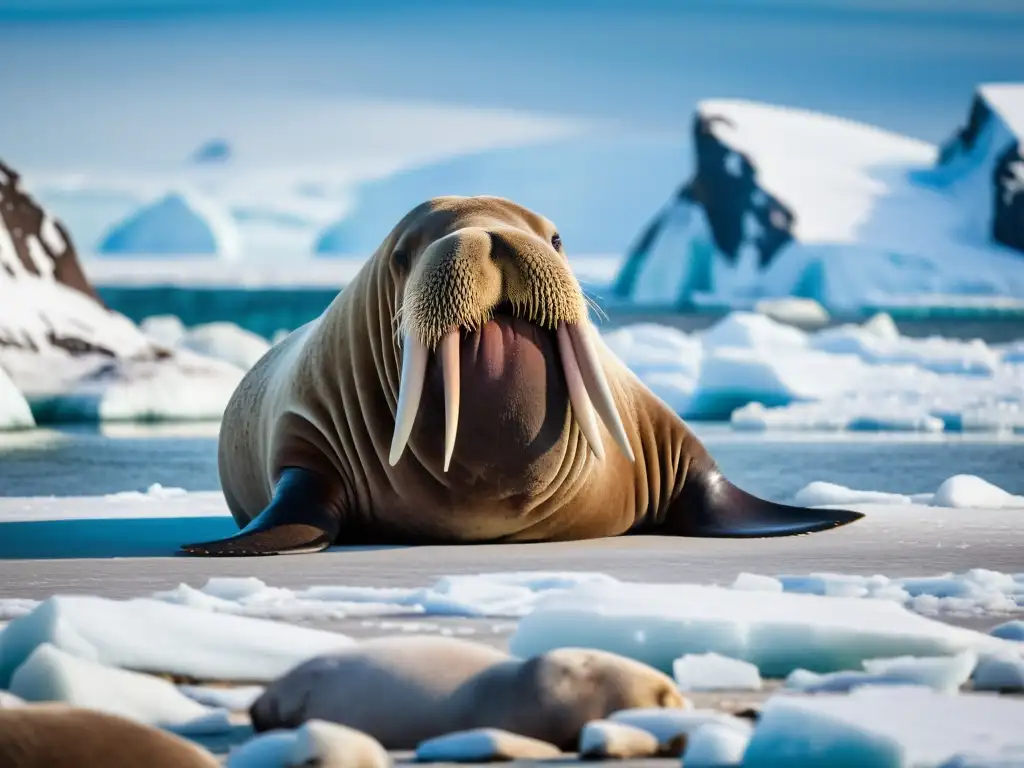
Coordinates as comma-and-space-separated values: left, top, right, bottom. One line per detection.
785, 650, 978, 693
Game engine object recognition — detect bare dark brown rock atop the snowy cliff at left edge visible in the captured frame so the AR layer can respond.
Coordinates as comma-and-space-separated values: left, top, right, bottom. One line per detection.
0, 160, 102, 304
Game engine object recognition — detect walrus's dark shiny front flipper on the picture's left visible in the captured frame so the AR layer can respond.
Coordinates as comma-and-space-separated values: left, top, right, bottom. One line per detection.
181, 469, 341, 557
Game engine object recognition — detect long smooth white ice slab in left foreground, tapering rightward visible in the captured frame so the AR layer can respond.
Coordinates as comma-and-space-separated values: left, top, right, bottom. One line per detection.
0, 595, 354, 685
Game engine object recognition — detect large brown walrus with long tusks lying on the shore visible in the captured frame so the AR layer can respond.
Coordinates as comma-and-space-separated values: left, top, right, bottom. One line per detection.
182, 197, 862, 555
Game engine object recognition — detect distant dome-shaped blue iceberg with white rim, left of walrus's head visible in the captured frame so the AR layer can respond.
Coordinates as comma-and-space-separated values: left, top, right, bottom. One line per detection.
96, 190, 242, 261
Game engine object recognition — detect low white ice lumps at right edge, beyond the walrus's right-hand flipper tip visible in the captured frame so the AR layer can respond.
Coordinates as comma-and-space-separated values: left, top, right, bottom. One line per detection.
794, 475, 1024, 510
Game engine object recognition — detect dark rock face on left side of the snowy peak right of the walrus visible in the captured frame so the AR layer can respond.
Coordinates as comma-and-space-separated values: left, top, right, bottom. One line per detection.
612, 112, 797, 299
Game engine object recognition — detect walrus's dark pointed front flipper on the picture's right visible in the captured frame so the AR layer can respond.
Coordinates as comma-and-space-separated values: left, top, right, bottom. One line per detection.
664, 469, 863, 539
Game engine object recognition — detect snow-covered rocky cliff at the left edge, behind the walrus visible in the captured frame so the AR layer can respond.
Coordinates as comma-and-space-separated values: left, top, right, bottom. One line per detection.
0, 163, 243, 426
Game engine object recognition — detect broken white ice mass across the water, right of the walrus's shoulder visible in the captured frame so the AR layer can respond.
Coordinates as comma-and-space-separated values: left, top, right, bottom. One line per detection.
602, 313, 1024, 433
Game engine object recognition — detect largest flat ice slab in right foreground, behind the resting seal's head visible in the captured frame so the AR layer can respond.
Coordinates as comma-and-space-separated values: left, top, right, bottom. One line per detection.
510, 577, 1007, 676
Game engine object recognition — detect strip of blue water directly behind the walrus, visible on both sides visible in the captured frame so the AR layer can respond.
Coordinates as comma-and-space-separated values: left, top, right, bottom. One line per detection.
0, 425, 1024, 501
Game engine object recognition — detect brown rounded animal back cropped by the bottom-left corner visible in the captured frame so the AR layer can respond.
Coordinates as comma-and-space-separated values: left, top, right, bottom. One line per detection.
0, 703, 220, 768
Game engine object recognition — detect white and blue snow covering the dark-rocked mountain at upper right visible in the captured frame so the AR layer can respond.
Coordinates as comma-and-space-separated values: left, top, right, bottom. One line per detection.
618, 92, 1024, 310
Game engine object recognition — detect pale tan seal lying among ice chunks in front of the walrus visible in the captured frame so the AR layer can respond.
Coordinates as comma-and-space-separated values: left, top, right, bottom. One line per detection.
249, 635, 688, 751
